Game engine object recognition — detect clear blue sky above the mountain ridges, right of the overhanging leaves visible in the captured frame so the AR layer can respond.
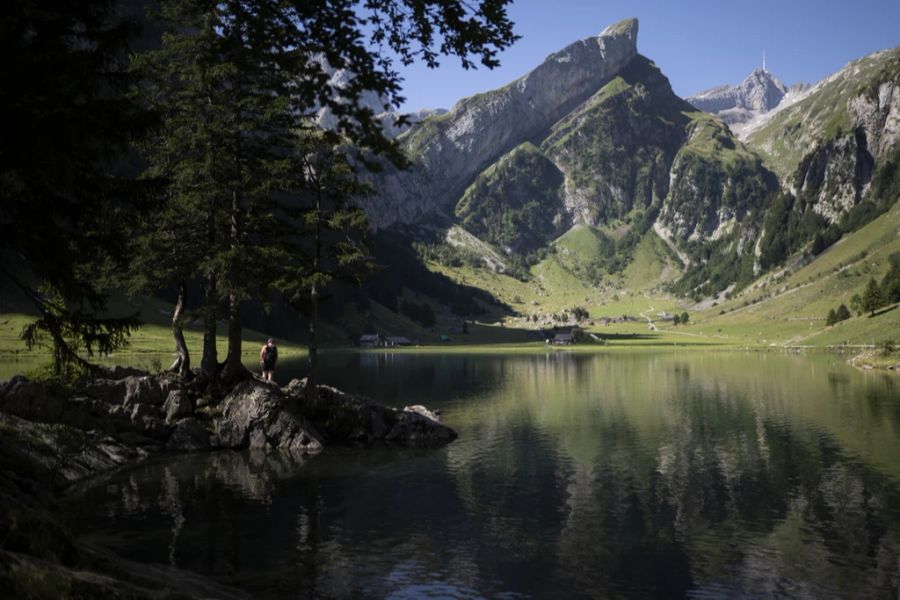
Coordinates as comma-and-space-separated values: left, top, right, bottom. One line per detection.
401, 0, 900, 111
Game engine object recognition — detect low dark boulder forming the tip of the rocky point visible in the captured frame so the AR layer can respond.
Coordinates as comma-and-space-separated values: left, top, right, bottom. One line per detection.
285, 380, 457, 447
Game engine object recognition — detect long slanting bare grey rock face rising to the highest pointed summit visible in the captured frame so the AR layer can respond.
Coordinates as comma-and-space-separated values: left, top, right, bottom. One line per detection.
367, 19, 638, 227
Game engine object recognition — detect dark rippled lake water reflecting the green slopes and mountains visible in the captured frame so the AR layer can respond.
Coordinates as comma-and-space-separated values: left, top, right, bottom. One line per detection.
65, 352, 900, 598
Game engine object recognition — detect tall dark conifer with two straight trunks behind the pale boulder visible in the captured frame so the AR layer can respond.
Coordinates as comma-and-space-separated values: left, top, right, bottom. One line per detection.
135, 0, 297, 379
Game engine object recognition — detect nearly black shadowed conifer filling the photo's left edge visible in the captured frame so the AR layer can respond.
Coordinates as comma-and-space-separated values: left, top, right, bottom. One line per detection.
0, 0, 148, 374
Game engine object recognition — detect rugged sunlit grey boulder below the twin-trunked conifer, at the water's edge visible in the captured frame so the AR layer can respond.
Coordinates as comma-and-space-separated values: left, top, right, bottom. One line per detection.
216, 380, 322, 452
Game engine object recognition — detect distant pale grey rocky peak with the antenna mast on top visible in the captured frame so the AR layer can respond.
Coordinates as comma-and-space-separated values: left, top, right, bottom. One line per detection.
687, 68, 788, 125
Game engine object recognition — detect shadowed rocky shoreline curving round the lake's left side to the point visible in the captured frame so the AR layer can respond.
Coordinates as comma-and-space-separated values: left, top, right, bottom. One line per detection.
0, 369, 457, 599
